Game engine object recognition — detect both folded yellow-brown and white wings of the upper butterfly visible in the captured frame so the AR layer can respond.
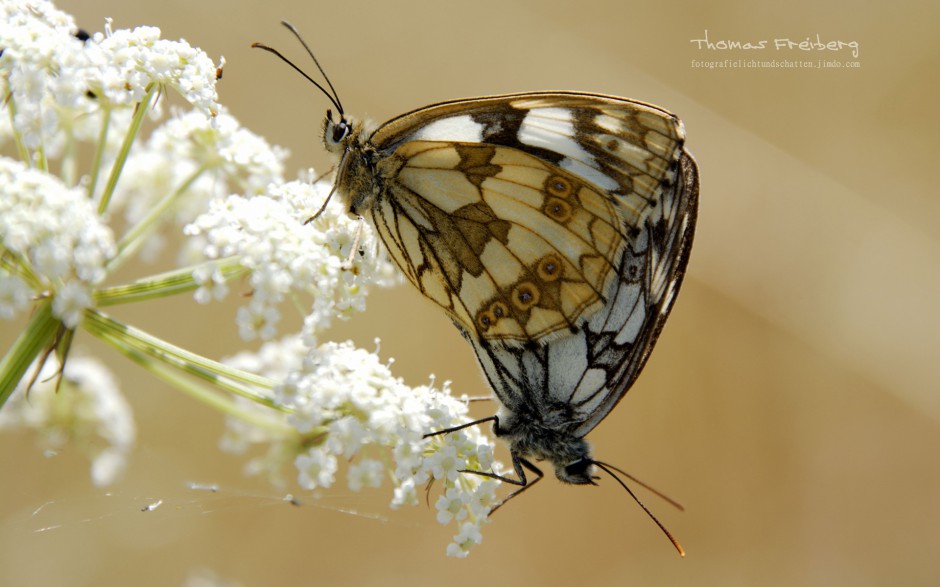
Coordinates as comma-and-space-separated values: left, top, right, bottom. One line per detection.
358, 92, 683, 346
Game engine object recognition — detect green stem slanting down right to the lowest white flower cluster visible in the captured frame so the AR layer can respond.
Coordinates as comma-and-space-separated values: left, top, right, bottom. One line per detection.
82, 310, 287, 412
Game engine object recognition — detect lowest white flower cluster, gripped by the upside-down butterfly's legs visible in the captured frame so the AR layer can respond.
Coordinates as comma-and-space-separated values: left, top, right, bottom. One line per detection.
223, 337, 499, 557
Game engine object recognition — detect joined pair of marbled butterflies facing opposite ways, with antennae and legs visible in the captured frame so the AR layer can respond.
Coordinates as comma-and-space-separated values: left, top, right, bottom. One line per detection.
255, 23, 698, 553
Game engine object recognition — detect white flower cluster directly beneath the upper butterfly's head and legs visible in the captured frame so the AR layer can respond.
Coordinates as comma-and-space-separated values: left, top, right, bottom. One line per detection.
185, 181, 395, 346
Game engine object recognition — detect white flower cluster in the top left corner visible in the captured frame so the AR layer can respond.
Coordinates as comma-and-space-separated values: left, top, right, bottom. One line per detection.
0, 0, 219, 156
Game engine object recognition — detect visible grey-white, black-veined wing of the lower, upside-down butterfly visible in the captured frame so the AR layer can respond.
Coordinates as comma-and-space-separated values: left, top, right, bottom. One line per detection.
468, 154, 698, 438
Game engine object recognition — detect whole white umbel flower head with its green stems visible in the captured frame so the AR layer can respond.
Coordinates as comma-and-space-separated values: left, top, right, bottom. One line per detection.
0, 0, 499, 556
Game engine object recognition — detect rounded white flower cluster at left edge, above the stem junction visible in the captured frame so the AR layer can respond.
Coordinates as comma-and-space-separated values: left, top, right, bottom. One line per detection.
0, 157, 115, 328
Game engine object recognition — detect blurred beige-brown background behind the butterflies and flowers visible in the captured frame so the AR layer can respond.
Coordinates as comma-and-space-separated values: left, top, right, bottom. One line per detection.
0, 0, 940, 587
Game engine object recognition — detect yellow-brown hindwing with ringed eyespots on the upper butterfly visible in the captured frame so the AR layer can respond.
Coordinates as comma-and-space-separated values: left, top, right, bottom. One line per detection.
373, 141, 627, 342
